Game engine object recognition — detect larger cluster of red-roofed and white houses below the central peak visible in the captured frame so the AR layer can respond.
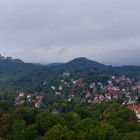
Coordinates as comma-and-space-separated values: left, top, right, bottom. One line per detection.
47, 73, 140, 105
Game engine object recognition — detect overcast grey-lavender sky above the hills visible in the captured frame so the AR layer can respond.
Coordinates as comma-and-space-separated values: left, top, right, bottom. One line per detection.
0, 0, 140, 65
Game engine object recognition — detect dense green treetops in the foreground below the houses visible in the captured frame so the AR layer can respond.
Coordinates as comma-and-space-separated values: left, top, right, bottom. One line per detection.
0, 100, 140, 140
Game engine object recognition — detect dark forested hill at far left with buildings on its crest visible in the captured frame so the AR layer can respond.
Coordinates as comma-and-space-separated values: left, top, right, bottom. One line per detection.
0, 58, 44, 82
